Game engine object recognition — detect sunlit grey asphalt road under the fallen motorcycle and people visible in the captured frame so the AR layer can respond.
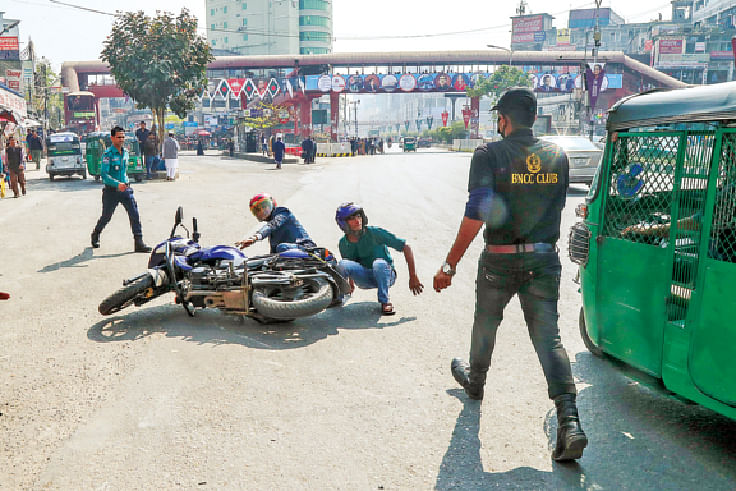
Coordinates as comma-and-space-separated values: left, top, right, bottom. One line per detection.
0, 149, 736, 490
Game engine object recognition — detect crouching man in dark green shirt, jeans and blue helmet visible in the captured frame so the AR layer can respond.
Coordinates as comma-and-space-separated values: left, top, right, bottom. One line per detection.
335, 203, 424, 315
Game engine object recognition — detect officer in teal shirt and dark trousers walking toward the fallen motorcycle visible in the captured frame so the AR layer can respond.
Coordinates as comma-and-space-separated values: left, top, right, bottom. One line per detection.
91, 126, 151, 252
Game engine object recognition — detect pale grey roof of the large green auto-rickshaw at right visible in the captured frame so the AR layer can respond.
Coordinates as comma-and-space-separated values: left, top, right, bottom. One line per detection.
607, 82, 736, 130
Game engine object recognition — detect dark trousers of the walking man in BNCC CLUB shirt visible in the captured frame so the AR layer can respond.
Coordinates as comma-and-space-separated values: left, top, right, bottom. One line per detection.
470, 251, 575, 399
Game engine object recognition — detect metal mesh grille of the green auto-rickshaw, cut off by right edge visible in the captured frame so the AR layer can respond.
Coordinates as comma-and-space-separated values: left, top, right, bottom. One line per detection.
708, 133, 736, 263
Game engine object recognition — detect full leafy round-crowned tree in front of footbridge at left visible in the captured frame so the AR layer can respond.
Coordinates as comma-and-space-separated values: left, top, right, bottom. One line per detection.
100, 9, 213, 147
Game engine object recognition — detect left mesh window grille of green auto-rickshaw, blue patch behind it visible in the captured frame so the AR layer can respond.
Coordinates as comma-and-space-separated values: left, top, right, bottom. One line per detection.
602, 133, 679, 245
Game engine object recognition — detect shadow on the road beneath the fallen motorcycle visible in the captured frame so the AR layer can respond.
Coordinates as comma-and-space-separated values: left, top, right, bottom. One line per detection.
87, 302, 416, 349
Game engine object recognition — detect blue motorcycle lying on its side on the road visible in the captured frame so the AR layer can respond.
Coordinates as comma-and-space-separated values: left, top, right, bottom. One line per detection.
99, 207, 350, 322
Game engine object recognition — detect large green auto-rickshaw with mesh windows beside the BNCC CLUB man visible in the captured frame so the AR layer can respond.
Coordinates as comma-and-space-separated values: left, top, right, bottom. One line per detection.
569, 82, 736, 419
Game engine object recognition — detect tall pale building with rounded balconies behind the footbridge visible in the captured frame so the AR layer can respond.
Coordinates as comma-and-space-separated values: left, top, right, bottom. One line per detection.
206, 0, 332, 55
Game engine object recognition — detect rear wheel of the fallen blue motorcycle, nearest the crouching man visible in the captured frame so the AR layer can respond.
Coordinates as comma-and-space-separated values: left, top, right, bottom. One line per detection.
253, 280, 332, 320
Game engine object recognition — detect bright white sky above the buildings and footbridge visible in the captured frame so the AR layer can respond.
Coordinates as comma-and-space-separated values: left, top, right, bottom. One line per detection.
5, 0, 671, 70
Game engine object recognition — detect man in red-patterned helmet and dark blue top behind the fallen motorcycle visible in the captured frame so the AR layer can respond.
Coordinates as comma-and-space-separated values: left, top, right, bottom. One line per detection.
235, 193, 317, 253
